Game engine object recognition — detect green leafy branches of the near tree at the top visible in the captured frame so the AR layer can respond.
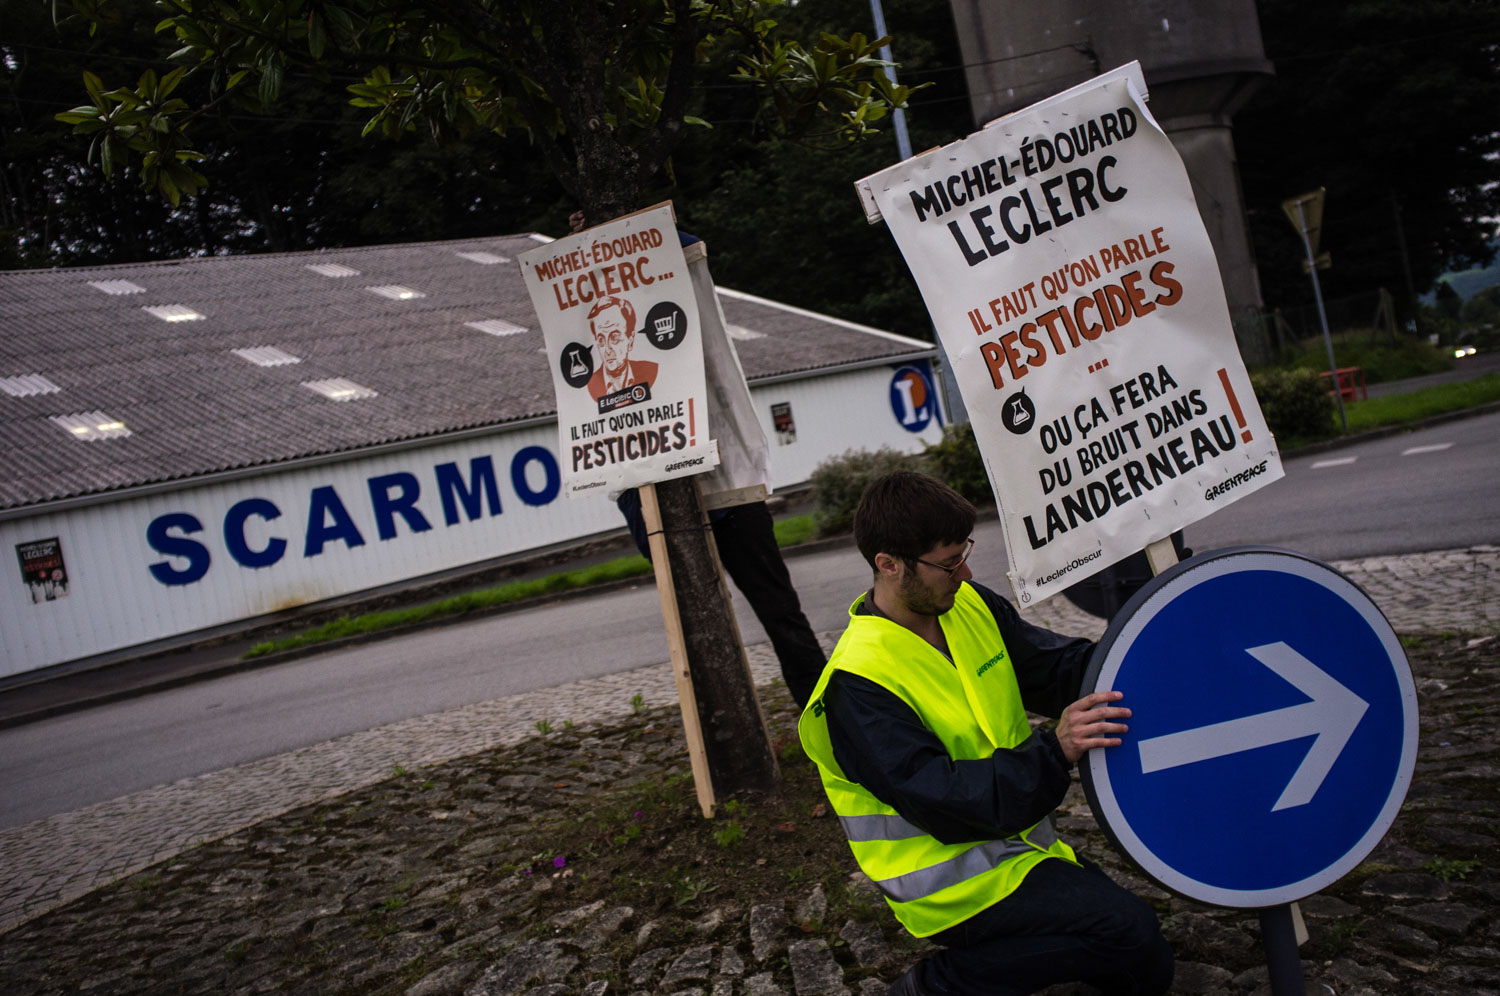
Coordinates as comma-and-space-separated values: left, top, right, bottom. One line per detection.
59, 0, 912, 222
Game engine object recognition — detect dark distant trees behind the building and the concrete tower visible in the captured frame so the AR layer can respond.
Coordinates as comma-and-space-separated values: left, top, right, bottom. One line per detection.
0, 0, 1500, 338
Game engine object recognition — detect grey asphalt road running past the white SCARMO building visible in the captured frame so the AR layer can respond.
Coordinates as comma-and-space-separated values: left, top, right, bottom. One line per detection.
0, 414, 1500, 828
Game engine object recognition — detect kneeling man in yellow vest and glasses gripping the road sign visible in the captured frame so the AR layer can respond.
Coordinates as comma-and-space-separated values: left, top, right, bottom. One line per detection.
798, 471, 1173, 996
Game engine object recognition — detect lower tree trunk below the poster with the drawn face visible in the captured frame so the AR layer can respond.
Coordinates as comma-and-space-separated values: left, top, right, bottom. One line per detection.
656, 477, 780, 798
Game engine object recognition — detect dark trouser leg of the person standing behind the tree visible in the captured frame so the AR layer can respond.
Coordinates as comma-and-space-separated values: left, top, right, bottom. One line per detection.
713, 501, 827, 708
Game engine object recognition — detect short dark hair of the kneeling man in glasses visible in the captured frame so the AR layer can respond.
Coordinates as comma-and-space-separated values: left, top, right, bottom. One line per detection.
854, 471, 978, 570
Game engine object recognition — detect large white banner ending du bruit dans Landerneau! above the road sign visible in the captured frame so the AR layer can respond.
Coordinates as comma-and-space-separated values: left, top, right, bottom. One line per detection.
858, 63, 1281, 603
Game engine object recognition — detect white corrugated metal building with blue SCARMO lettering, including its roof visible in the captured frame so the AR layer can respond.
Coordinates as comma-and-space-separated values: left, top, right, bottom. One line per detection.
0, 234, 941, 681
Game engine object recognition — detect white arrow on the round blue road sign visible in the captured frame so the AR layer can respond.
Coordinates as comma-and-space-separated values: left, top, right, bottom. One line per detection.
1140, 642, 1370, 813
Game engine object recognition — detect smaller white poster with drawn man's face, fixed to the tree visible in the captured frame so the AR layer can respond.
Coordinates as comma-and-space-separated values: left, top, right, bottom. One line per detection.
521, 204, 719, 498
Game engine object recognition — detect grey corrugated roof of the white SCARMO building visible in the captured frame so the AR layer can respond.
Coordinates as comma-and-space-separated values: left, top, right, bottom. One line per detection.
0, 234, 932, 509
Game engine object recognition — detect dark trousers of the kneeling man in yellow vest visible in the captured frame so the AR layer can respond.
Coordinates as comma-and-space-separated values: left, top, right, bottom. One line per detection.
918, 860, 1173, 996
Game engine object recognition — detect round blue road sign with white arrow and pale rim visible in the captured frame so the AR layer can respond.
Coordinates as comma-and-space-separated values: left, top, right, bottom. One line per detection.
1083, 549, 1418, 908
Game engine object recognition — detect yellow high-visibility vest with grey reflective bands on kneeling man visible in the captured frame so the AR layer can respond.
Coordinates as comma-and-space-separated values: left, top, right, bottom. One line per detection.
797, 584, 1077, 938
